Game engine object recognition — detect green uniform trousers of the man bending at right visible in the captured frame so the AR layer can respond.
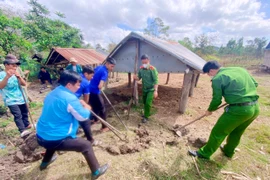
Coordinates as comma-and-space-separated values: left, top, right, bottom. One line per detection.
198, 103, 260, 159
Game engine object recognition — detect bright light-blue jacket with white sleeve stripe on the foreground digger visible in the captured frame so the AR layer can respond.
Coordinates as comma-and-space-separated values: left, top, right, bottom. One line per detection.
37, 85, 90, 141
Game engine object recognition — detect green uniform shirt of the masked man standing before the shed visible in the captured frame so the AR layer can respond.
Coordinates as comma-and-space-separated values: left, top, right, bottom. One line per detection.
138, 65, 158, 92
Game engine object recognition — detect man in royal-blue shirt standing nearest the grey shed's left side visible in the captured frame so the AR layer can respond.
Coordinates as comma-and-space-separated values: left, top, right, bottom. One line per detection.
89, 58, 116, 132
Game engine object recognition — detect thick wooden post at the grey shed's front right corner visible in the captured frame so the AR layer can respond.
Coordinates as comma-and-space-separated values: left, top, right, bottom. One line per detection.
179, 70, 192, 114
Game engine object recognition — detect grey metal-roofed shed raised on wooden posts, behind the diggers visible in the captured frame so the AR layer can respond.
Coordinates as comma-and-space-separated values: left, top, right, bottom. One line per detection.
107, 32, 206, 113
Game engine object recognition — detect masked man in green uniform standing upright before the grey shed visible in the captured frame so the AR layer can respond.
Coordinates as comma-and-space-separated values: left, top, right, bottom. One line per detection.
134, 54, 158, 123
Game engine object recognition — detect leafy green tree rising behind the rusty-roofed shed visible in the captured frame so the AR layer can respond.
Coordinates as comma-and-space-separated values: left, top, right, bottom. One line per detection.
23, 0, 83, 52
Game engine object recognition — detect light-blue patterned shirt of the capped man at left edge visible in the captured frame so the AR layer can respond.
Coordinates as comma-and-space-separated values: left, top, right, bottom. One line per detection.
0, 71, 25, 106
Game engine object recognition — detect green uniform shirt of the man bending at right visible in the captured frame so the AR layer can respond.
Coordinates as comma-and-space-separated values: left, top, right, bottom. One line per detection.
208, 67, 259, 111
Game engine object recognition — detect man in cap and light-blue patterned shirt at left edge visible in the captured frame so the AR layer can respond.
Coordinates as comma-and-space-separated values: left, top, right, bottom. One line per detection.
0, 54, 32, 137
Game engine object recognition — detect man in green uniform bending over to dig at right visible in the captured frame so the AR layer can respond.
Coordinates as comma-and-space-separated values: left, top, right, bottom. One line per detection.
189, 61, 260, 159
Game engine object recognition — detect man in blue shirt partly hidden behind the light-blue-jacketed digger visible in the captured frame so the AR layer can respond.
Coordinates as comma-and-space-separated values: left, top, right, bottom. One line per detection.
75, 65, 96, 145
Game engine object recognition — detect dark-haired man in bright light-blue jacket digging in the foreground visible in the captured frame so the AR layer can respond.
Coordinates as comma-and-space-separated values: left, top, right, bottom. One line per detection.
37, 71, 108, 179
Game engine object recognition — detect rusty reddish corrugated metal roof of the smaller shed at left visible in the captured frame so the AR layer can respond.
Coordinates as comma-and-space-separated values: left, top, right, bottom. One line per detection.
46, 48, 106, 65
